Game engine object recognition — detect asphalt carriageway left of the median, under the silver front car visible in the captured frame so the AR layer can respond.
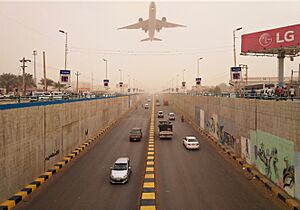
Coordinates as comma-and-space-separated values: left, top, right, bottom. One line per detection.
16, 107, 151, 210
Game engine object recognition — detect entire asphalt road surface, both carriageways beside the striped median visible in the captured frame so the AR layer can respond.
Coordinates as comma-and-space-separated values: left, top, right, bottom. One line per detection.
15, 102, 287, 210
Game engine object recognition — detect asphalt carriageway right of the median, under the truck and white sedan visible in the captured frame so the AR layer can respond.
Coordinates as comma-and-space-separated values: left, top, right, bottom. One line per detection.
156, 106, 288, 210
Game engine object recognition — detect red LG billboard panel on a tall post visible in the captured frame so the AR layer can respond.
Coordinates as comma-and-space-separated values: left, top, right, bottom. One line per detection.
241, 24, 300, 55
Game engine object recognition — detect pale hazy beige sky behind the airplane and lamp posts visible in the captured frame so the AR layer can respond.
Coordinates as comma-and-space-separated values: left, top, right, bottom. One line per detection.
0, 1, 300, 90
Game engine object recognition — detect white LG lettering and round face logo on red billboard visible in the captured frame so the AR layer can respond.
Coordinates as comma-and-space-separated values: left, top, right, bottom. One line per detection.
258, 31, 295, 47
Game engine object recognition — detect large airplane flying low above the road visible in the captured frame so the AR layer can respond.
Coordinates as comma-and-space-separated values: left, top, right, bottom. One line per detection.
118, 2, 186, 42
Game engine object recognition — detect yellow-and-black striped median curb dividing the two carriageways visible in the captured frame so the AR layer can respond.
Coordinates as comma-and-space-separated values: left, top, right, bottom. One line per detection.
140, 97, 156, 210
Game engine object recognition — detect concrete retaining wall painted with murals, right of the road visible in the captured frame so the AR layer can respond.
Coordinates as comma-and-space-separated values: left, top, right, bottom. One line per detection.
164, 94, 300, 199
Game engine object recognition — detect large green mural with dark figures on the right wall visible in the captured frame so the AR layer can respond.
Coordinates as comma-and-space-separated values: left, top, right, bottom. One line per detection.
250, 130, 296, 197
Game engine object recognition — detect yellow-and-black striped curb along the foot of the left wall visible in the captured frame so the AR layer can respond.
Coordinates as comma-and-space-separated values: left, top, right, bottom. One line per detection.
0, 106, 135, 210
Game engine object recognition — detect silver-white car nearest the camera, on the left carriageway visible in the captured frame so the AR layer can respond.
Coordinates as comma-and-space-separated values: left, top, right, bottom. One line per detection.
110, 157, 131, 184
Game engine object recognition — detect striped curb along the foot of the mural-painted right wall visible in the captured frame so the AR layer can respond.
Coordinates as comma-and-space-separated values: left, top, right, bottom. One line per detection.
173, 106, 300, 210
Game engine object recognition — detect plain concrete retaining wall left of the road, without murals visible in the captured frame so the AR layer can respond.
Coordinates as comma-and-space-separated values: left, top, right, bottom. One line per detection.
0, 95, 139, 203
